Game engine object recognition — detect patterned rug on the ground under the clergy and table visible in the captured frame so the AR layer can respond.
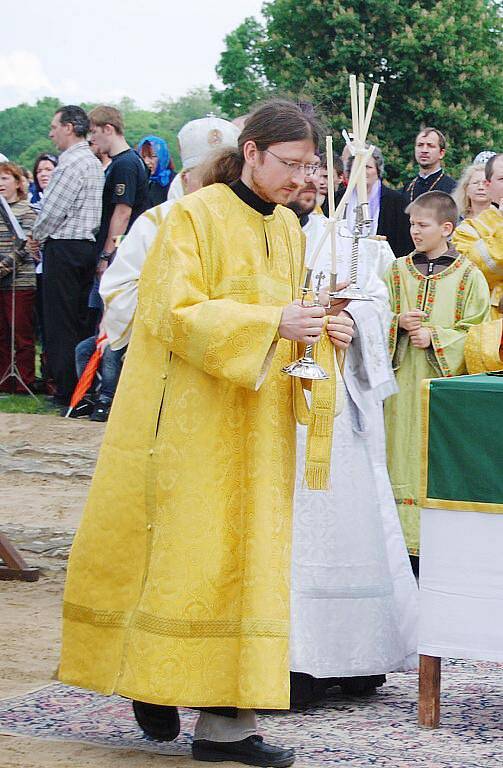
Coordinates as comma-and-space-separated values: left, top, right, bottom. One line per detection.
0, 661, 503, 768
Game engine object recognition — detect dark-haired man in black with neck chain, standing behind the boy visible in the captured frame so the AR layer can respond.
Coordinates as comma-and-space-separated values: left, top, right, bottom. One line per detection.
403, 127, 456, 205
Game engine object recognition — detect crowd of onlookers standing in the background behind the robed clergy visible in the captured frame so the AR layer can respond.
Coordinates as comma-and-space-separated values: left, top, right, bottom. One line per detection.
0, 106, 498, 420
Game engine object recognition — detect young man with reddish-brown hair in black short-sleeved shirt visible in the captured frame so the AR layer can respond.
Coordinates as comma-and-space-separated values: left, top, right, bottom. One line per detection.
89, 106, 149, 276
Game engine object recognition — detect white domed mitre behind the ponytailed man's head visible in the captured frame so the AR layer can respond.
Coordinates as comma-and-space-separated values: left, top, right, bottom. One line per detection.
178, 114, 240, 171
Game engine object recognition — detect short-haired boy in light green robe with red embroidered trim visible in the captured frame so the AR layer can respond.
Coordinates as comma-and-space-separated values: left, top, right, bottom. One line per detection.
385, 191, 489, 555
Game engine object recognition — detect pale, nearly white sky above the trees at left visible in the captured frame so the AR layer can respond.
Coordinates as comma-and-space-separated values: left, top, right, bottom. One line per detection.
0, 0, 263, 109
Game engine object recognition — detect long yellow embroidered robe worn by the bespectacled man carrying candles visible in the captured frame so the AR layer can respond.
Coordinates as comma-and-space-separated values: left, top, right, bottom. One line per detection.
60, 184, 303, 708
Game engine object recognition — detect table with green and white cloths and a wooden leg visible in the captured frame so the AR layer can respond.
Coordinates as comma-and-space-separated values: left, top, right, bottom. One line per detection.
418, 374, 503, 727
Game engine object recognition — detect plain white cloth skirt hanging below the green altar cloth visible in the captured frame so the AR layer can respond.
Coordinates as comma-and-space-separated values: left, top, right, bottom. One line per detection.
418, 509, 503, 662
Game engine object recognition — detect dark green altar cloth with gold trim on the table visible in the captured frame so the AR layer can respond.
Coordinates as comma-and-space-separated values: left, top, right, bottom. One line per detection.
421, 373, 503, 513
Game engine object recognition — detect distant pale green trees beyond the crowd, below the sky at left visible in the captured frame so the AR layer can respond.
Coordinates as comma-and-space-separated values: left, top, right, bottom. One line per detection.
0, 88, 220, 168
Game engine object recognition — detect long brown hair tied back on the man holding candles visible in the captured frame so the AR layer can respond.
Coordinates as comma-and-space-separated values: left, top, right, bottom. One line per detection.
201, 99, 320, 187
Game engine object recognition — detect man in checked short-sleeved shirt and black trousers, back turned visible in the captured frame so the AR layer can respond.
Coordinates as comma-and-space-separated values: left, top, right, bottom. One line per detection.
33, 105, 105, 405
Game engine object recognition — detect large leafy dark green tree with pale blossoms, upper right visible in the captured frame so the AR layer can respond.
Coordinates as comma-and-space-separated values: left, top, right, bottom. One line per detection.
213, 0, 503, 183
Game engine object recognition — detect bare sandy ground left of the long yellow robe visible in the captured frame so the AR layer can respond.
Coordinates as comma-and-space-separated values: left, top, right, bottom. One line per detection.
0, 413, 207, 768
